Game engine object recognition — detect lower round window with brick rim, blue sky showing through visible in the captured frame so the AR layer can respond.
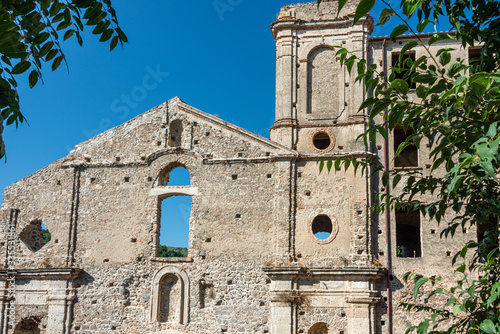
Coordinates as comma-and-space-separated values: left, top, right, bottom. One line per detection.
307, 209, 339, 245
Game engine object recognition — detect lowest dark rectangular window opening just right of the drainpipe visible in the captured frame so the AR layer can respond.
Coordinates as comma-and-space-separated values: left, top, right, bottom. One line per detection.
396, 210, 422, 257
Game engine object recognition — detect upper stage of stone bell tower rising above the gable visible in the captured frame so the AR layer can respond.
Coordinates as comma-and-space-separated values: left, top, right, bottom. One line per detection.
271, 1, 373, 154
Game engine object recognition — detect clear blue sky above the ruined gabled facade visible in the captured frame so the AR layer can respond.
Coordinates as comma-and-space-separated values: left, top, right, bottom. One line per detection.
0, 0, 446, 248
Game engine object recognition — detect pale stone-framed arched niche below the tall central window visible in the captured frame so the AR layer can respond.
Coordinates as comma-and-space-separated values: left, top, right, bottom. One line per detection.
151, 266, 189, 325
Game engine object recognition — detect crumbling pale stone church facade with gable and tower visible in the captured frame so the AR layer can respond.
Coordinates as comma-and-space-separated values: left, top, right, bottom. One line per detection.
0, 1, 474, 334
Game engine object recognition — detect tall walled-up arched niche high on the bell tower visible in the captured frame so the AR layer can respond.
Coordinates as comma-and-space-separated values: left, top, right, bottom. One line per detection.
307, 45, 341, 118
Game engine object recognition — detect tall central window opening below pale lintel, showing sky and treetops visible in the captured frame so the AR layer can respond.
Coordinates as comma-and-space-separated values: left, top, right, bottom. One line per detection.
158, 196, 192, 257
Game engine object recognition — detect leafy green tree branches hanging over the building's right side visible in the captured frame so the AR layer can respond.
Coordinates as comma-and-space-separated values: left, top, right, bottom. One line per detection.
318, 0, 500, 333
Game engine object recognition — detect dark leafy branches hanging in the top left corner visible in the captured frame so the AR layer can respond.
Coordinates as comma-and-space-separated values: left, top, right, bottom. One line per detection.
0, 0, 127, 158
